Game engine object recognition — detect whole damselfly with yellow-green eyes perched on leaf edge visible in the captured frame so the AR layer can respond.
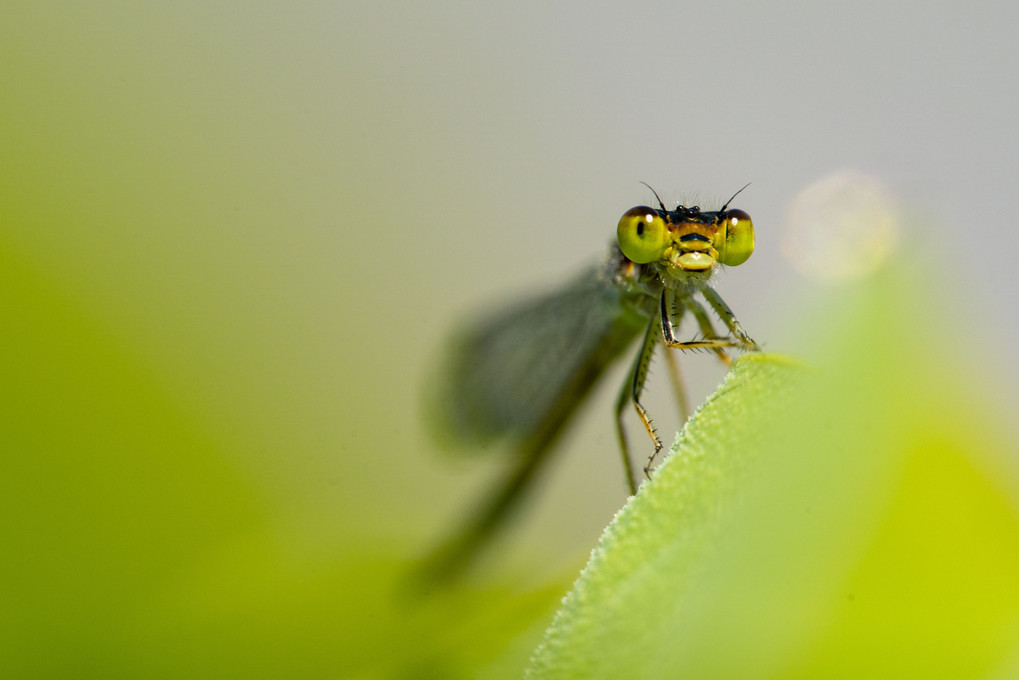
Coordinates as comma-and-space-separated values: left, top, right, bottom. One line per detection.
425, 187, 758, 569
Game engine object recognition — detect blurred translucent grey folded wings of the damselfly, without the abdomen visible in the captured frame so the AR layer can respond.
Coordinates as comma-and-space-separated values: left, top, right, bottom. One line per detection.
436, 254, 646, 442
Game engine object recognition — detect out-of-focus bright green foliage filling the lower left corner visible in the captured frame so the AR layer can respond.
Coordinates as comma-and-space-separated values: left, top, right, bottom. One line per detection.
0, 240, 561, 678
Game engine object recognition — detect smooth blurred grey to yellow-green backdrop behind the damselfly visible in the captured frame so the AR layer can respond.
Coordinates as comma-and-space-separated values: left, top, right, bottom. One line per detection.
7, 0, 1019, 587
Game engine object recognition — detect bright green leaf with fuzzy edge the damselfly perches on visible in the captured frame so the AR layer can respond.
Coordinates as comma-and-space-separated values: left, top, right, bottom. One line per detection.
529, 265, 1019, 679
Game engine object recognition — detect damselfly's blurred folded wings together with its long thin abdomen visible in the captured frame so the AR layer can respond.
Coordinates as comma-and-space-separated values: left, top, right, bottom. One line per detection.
422, 250, 655, 581
